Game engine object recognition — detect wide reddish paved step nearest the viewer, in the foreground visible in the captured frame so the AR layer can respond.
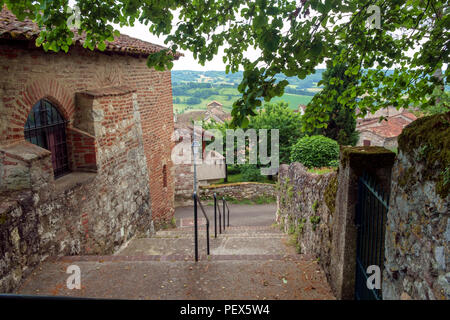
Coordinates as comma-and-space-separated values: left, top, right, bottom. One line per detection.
15, 256, 334, 300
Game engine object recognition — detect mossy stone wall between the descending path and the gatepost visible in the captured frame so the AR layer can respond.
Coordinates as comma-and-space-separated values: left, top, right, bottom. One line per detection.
277, 163, 337, 277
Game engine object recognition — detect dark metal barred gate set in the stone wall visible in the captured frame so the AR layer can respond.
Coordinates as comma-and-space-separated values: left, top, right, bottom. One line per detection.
355, 174, 389, 300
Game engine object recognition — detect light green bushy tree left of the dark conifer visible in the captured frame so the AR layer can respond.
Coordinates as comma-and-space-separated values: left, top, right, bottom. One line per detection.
249, 102, 303, 163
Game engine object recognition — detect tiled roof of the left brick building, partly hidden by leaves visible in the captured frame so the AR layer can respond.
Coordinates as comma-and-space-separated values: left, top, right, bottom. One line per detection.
0, 8, 182, 59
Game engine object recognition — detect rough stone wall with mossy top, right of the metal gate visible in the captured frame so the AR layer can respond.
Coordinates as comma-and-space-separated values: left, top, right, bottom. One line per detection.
382, 113, 450, 299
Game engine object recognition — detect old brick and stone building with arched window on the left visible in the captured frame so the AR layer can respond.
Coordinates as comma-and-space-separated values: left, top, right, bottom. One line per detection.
0, 9, 179, 292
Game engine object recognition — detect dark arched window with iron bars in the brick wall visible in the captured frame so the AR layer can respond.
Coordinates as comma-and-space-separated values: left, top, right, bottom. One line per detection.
25, 100, 69, 178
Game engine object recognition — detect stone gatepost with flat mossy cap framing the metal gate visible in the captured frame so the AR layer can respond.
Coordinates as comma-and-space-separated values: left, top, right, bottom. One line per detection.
330, 147, 395, 299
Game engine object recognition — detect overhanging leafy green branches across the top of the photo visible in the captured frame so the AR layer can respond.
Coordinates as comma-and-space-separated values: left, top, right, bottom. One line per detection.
0, 0, 450, 126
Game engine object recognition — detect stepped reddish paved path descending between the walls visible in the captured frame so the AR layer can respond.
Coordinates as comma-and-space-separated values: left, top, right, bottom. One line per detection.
17, 205, 334, 300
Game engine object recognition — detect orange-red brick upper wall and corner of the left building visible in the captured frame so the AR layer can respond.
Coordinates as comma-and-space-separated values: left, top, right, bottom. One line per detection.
0, 40, 173, 224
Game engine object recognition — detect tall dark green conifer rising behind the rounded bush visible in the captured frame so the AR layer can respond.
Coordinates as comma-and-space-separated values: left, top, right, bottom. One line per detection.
304, 52, 358, 146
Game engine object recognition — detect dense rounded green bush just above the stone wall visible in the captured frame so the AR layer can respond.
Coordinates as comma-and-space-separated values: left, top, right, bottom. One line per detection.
291, 135, 339, 168
